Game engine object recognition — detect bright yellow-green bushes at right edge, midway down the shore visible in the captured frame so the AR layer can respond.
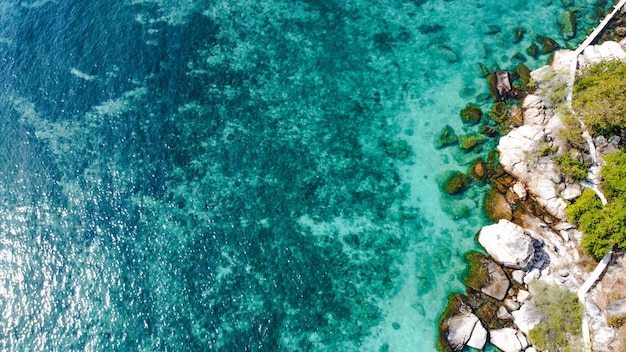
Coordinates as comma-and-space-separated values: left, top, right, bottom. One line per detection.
566, 152, 626, 260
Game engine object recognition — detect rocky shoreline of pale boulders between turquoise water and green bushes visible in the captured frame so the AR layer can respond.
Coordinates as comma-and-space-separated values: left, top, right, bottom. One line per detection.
440, 40, 626, 352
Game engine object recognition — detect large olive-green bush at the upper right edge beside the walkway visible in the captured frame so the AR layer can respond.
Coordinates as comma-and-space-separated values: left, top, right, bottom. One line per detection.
572, 60, 626, 136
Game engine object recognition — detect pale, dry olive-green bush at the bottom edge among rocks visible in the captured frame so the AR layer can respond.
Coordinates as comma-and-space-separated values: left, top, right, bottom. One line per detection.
528, 281, 584, 352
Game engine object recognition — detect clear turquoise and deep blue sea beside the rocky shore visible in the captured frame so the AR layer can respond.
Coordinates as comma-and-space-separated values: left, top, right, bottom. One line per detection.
0, 0, 608, 351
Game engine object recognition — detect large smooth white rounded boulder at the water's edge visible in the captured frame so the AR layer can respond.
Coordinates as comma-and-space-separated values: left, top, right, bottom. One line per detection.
478, 219, 535, 269
